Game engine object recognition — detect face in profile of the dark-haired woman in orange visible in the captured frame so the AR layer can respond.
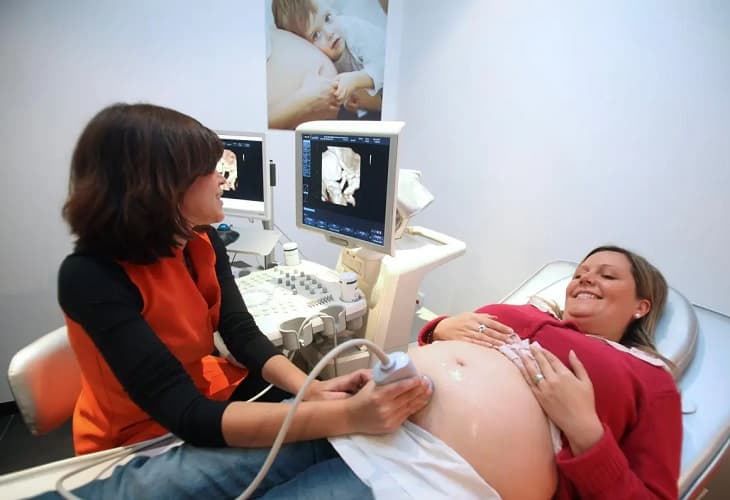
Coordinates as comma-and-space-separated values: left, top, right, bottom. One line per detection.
180, 170, 226, 227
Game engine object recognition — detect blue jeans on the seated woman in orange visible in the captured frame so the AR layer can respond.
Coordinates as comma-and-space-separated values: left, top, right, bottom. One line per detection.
31, 439, 373, 500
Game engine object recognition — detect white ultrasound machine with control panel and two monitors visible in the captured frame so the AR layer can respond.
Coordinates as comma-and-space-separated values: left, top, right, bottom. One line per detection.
217, 121, 466, 377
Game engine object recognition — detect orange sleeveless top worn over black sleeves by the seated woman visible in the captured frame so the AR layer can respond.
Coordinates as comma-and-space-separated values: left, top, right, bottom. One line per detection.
66, 233, 248, 454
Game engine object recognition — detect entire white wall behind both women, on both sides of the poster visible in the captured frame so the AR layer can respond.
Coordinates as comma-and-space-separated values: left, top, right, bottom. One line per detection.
0, 0, 730, 402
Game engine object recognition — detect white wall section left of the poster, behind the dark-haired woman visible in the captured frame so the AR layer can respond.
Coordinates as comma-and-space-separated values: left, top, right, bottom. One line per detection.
0, 0, 266, 402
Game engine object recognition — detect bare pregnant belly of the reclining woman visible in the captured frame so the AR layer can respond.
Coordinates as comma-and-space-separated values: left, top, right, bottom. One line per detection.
409, 341, 557, 499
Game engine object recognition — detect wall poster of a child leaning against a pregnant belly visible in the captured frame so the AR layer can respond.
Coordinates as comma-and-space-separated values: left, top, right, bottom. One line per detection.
266, 0, 388, 130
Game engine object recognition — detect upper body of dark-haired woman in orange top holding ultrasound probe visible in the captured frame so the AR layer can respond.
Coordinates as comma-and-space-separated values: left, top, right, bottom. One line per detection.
58, 104, 430, 460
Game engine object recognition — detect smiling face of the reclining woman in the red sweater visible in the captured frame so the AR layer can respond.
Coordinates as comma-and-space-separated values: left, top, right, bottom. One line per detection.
563, 251, 651, 342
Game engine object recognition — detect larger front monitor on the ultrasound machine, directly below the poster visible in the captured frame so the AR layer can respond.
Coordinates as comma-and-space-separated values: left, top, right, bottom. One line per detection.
295, 121, 403, 255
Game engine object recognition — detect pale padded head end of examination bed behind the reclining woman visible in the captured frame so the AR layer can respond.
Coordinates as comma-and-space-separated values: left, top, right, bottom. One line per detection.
502, 261, 730, 499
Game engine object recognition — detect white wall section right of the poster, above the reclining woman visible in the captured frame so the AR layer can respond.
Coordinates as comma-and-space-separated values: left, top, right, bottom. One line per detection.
386, 0, 730, 313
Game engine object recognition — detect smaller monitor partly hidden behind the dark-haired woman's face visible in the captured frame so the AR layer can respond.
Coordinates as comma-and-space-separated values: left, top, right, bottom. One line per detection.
216, 132, 271, 220
